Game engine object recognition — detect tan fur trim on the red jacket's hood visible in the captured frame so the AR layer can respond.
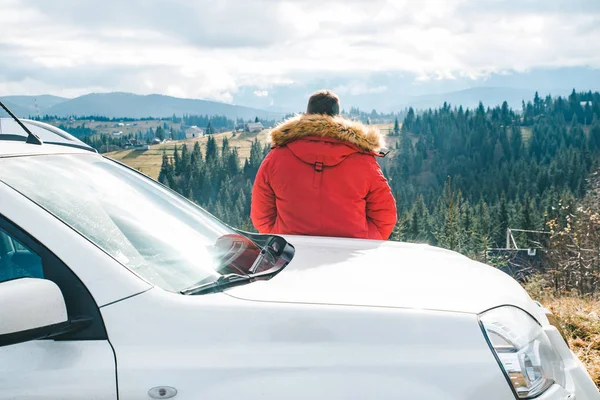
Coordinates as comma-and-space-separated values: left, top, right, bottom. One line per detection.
270, 114, 384, 153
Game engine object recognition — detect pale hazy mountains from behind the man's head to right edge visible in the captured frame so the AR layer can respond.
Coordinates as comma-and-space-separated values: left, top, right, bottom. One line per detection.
233, 67, 600, 112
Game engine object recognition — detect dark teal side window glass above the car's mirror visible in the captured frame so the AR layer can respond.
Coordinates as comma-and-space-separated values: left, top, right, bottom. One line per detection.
0, 228, 44, 282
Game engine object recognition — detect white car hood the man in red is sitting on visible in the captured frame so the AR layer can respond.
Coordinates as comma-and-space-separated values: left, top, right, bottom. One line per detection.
226, 236, 542, 316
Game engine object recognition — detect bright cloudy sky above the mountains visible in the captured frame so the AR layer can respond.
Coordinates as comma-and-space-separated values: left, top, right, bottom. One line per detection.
0, 0, 600, 109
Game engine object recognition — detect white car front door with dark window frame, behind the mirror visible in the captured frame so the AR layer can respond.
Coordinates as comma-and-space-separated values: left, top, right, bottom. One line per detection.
0, 215, 117, 400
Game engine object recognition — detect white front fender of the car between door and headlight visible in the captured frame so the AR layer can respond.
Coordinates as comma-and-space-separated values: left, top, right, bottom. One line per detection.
102, 289, 512, 400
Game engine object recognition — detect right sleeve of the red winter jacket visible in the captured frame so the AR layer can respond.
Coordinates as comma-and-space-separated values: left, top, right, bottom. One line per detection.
367, 158, 398, 240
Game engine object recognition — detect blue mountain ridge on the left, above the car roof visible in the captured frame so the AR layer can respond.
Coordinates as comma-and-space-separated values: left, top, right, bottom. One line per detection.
0, 93, 282, 120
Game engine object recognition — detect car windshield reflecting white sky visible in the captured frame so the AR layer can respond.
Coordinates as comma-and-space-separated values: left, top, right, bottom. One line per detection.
0, 155, 260, 292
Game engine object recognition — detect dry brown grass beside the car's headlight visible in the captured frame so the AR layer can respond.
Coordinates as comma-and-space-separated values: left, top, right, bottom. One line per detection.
525, 280, 600, 388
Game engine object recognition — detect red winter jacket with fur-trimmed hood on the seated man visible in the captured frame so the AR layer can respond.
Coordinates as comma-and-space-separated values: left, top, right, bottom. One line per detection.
251, 114, 396, 240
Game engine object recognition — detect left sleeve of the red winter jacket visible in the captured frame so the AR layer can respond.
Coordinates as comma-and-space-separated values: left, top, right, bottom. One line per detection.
250, 153, 277, 233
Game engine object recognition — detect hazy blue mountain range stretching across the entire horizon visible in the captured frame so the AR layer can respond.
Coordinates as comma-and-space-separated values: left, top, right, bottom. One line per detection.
0, 67, 600, 119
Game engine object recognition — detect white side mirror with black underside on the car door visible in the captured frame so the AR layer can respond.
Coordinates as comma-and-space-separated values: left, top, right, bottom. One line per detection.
0, 278, 69, 346
